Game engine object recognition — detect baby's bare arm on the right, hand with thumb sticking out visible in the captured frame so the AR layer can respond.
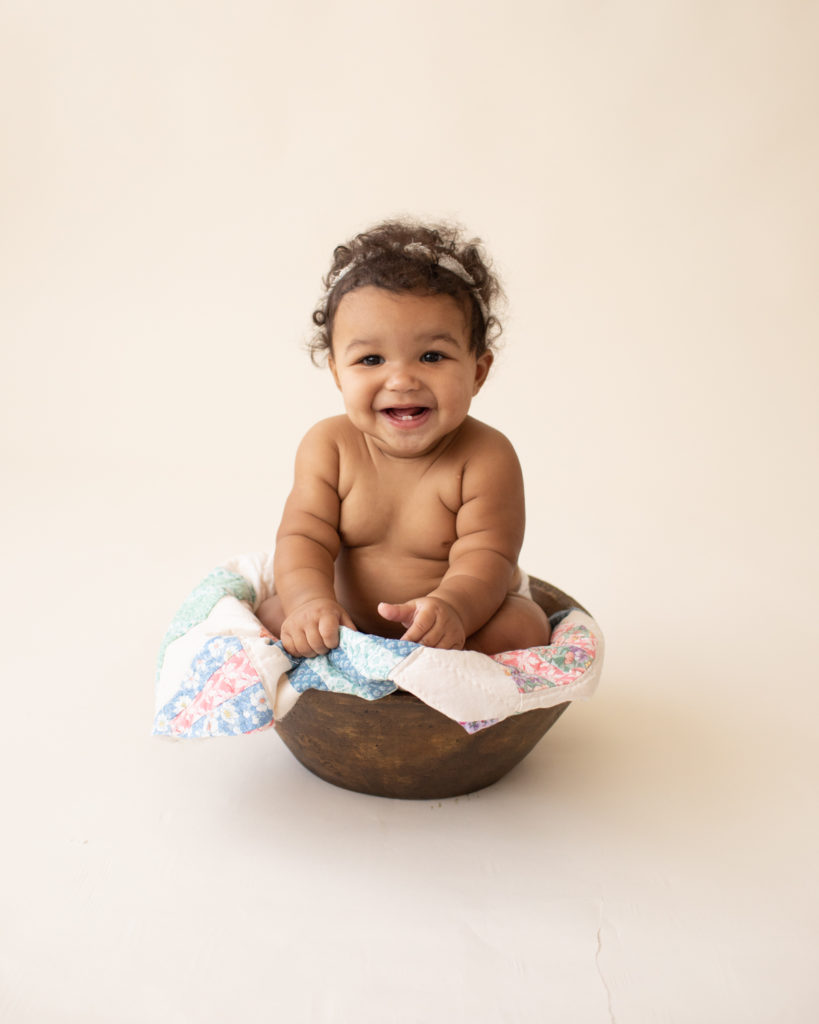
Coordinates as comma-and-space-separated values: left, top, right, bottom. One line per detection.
378, 431, 525, 649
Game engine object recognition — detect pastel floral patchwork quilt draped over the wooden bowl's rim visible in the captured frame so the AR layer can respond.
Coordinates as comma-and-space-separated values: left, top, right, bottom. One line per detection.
154, 554, 604, 738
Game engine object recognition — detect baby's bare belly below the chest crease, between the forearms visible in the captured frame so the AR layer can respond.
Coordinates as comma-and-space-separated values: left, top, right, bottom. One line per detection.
336, 545, 448, 637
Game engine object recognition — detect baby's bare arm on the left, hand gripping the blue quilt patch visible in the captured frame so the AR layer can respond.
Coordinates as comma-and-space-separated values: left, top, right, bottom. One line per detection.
273, 421, 355, 657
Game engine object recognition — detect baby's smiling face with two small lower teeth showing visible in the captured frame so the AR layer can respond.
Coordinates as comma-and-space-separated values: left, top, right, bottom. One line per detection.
330, 286, 492, 458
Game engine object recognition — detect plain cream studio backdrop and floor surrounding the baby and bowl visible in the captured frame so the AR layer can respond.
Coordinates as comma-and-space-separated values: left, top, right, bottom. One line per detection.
0, 0, 819, 1024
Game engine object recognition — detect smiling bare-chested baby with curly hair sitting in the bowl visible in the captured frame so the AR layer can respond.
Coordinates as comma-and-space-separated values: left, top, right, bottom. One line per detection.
257, 222, 550, 657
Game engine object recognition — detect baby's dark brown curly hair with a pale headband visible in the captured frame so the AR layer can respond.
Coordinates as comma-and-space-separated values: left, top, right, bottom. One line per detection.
309, 220, 503, 364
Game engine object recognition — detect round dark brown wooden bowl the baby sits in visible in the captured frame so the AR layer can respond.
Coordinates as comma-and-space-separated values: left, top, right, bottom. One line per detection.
275, 577, 581, 800
